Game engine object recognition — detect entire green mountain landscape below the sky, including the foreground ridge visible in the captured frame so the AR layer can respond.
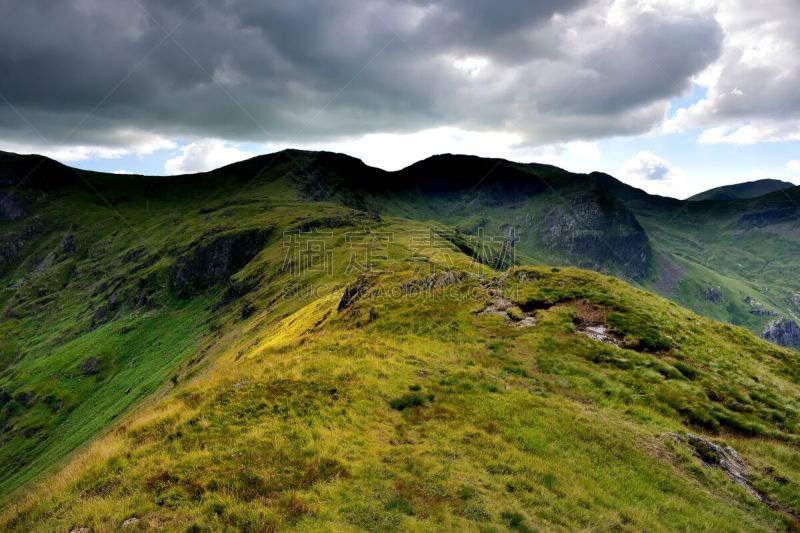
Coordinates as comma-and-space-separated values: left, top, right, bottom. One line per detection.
0, 151, 800, 531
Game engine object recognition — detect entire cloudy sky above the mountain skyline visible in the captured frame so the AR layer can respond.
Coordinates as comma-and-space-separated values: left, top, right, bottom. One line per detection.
0, 0, 800, 198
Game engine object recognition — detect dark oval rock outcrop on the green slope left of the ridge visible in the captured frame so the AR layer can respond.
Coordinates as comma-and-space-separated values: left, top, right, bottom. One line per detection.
169, 229, 272, 298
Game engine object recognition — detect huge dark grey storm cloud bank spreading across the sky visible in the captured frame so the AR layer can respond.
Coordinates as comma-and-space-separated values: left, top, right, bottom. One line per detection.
0, 0, 722, 150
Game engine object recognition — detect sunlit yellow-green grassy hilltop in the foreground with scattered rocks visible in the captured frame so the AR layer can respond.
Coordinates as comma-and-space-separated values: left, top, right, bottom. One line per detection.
0, 262, 800, 531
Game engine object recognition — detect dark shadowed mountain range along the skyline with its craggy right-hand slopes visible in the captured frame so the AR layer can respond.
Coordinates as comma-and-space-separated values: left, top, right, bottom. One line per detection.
0, 149, 800, 344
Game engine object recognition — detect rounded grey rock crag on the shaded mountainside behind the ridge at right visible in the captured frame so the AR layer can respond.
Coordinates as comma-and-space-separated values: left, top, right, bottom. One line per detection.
538, 194, 652, 279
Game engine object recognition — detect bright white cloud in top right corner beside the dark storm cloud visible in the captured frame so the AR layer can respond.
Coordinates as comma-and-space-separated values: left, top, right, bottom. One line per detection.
669, 0, 800, 145
